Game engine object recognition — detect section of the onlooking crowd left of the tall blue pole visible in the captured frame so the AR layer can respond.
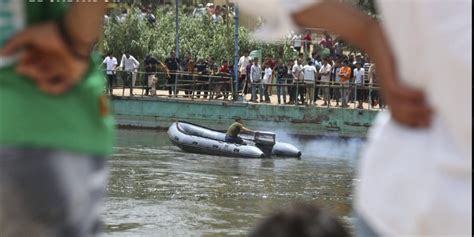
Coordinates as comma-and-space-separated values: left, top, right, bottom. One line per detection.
103, 51, 234, 100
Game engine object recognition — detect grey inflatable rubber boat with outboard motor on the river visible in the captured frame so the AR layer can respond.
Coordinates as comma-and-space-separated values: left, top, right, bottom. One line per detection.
168, 122, 301, 158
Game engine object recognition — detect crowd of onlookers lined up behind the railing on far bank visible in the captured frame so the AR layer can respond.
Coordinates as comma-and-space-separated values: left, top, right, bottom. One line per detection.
103, 47, 384, 108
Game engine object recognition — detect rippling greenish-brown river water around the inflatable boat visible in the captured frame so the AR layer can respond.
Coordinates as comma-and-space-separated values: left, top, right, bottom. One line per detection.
102, 130, 363, 237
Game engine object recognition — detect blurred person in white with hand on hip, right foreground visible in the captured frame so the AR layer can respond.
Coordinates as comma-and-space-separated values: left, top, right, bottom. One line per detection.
235, 0, 472, 236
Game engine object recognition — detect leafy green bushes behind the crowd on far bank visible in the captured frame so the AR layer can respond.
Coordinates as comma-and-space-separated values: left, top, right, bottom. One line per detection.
103, 9, 295, 66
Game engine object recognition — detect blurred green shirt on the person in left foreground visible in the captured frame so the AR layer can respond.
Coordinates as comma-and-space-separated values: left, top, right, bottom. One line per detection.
0, 0, 114, 155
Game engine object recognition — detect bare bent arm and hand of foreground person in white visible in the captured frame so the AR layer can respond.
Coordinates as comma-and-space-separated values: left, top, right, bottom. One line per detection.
293, 0, 431, 127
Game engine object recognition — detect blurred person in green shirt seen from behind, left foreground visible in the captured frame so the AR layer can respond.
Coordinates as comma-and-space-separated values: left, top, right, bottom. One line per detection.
0, 0, 114, 237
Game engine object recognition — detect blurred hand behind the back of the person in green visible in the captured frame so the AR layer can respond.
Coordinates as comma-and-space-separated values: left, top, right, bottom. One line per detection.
0, 22, 89, 94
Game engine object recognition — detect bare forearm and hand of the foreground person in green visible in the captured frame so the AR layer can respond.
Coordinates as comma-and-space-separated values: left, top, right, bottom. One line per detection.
0, 1, 106, 94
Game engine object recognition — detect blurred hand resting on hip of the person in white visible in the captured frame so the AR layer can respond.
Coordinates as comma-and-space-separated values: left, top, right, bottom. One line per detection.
382, 81, 432, 128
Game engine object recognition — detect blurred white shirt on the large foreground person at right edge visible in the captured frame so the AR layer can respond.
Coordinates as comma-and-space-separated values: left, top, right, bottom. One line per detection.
354, 0, 472, 236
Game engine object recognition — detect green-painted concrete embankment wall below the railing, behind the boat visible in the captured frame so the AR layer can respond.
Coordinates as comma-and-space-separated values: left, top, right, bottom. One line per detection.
111, 97, 377, 137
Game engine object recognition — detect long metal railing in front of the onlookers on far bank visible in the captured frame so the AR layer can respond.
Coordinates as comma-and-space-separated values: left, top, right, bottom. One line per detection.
104, 70, 385, 109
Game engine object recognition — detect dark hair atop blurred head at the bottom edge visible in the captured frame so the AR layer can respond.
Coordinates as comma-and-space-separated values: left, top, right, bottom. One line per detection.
249, 203, 349, 237
